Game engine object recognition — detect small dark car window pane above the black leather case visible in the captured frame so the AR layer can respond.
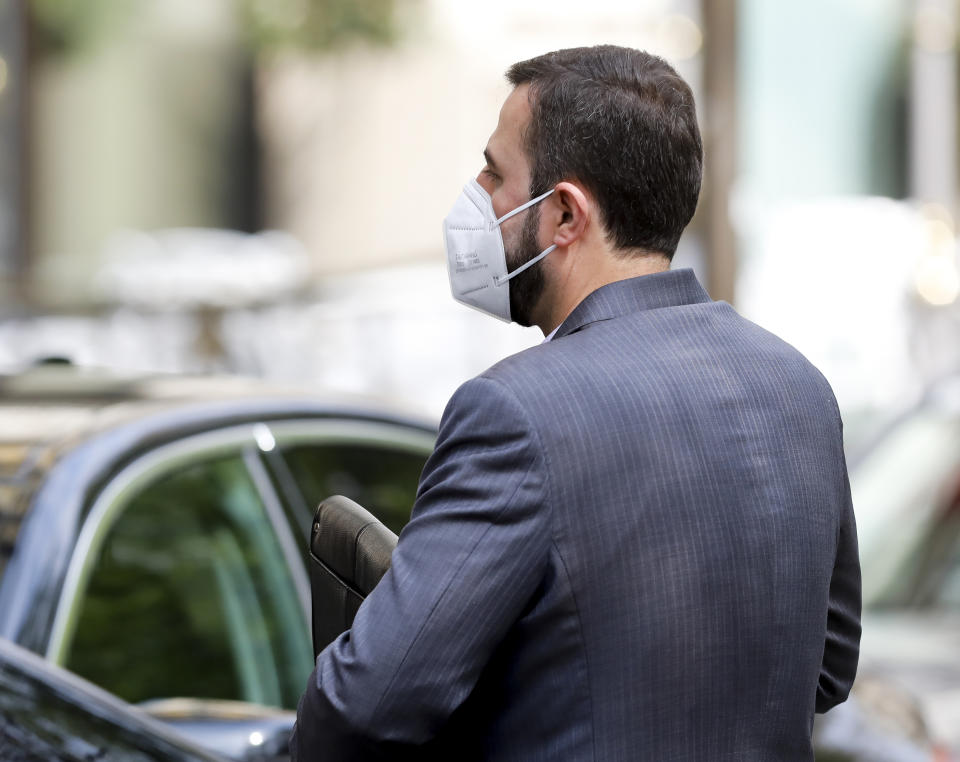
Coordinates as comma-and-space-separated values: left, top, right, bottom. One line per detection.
280, 442, 427, 534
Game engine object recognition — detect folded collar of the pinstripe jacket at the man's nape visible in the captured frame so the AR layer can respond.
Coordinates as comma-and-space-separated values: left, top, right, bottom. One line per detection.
553, 269, 710, 340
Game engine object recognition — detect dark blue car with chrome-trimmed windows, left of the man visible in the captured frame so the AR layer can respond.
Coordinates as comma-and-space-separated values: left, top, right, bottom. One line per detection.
0, 367, 435, 758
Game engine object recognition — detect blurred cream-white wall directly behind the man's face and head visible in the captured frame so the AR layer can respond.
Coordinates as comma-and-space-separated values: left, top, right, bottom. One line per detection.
258, 0, 702, 275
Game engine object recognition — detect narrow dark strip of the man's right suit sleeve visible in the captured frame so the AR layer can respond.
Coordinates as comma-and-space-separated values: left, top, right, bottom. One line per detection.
816, 434, 860, 712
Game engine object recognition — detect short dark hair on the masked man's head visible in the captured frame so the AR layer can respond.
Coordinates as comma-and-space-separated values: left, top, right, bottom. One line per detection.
507, 45, 703, 257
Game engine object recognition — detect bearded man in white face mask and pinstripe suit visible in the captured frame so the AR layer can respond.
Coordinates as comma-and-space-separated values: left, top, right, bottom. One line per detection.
292, 46, 860, 762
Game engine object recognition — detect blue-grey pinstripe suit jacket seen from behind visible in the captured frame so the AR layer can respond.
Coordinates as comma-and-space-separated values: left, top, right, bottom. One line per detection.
292, 270, 860, 762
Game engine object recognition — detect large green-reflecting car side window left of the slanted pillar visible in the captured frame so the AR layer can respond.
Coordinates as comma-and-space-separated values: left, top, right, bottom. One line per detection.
66, 455, 312, 708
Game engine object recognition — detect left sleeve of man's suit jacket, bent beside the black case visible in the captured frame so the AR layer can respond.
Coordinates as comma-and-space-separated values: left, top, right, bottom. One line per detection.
291, 377, 550, 760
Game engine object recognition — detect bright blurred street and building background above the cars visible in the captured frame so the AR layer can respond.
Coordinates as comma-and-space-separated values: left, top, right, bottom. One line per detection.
0, 0, 960, 420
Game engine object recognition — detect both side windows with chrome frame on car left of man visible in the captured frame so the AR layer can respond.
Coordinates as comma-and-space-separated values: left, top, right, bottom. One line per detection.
47, 417, 434, 709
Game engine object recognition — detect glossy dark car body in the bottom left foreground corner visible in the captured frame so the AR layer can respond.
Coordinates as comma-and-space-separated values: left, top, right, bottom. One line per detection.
0, 639, 228, 762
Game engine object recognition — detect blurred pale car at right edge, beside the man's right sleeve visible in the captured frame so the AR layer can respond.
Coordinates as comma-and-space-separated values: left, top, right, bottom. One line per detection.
819, 379, 960, 762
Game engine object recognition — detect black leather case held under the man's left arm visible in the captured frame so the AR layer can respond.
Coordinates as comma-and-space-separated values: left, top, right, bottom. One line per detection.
310, 495, 397, 657
